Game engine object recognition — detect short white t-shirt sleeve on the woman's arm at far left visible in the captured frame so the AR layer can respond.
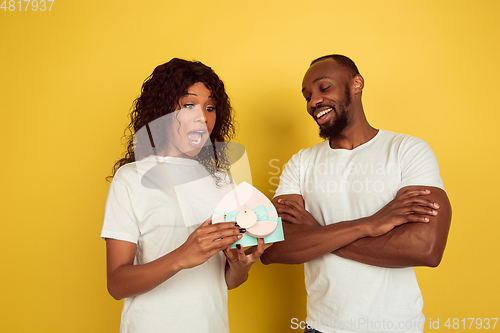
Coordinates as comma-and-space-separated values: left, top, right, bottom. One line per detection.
101, 178, 140, 244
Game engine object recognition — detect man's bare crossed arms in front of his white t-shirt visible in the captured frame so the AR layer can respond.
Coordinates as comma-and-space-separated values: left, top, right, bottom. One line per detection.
261, 186, 451, 267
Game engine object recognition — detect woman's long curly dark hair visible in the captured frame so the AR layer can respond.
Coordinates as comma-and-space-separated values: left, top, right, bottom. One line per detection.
108, 58, 235, 184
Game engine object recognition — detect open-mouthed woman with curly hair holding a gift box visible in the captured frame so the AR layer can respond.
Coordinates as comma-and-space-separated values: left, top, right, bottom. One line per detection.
101, 58, 267, 333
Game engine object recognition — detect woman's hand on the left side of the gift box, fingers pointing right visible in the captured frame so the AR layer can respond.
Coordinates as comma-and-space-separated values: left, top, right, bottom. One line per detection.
176, 218, 245, 269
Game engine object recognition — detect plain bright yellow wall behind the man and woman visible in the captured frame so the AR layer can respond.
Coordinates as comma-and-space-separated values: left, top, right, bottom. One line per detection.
0, 0, 500, 333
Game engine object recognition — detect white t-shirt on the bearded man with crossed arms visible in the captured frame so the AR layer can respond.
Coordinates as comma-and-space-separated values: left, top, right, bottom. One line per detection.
276, 130, 444, 333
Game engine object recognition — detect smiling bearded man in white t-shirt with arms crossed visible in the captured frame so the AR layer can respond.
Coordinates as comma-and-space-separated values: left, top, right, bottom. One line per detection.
261, 55, 451, 333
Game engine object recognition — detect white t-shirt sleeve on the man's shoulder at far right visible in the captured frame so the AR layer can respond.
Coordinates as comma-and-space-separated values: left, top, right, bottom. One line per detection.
400, 137, 444, 190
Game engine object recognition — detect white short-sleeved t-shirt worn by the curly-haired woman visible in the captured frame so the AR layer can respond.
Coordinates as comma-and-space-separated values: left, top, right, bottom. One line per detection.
101, 156, 232, 333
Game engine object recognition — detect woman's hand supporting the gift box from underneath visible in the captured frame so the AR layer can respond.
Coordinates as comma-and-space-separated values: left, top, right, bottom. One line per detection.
224, 238, 273, 289
